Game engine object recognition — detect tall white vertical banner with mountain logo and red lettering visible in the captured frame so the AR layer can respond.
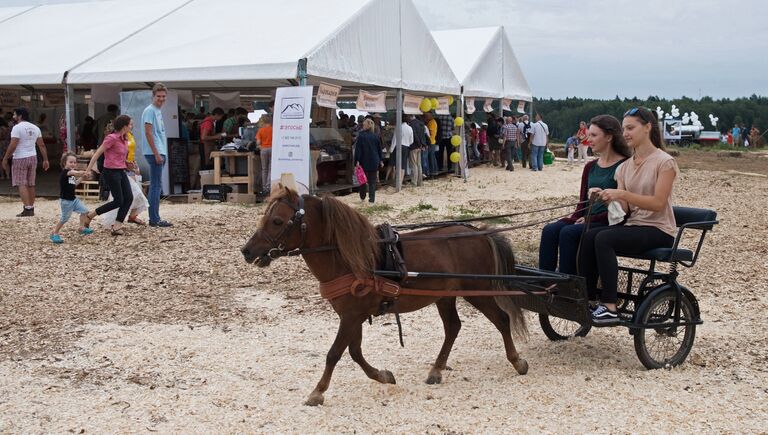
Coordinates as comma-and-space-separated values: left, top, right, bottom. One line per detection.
269, 86, 312, 194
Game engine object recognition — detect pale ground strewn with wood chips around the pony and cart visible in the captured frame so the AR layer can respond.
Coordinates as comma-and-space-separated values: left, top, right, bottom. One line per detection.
0, 152, 768, 433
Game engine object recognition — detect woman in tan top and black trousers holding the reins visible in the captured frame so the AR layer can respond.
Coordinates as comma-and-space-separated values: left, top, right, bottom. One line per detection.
579, 107, 678, 324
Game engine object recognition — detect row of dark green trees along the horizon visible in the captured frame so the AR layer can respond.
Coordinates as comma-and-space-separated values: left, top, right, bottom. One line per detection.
533, 95, 768, 141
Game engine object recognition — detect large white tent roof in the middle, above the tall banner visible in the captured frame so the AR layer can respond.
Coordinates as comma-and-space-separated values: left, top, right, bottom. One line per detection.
67, 0, 460, 95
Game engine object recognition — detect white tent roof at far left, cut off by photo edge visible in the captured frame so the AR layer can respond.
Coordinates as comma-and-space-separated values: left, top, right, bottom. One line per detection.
0, 0, 188, 86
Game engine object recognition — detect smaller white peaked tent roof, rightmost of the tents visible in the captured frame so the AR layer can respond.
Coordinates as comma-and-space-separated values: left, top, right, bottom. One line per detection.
432, 27, 532, 101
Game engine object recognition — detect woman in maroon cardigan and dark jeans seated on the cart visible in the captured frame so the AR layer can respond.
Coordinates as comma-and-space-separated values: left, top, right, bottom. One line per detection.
539, 115, 632, 275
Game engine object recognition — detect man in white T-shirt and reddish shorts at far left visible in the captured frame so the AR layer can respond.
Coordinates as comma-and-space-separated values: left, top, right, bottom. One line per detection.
3, 107, 50, 217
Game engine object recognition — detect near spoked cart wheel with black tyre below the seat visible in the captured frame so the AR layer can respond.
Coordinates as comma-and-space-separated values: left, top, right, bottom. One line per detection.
635, 290, 697, 369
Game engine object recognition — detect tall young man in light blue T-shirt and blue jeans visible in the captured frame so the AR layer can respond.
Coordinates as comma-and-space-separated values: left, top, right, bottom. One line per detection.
141, 83, 173, 227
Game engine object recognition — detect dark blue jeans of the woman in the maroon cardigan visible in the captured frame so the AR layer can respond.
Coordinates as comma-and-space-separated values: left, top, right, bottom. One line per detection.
539, 221, 605, 275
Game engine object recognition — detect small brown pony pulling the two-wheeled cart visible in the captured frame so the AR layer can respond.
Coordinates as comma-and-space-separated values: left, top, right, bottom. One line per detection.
241, 187, 528, 405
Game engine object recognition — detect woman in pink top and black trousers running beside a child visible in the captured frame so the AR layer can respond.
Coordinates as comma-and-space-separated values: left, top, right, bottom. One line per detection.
85, 115, 136, 236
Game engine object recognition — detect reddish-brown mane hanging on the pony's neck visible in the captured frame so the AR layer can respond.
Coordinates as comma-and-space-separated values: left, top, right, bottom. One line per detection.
323, 196, 381, 278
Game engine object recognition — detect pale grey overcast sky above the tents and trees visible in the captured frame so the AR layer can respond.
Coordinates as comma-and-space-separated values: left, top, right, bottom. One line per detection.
0, 0, 768, 98
